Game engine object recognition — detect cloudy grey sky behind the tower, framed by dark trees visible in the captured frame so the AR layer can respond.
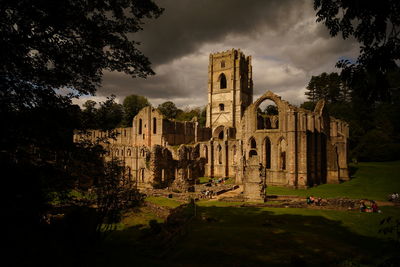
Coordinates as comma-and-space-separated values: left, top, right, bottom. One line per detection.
77, 0, 359, 108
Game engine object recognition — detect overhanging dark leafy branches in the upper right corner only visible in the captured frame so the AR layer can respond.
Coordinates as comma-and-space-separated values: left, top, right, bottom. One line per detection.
314, 0, 400, 102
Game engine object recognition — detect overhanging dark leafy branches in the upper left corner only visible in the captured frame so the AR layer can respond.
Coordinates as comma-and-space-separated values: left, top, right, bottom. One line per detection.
0, 0, 162, 94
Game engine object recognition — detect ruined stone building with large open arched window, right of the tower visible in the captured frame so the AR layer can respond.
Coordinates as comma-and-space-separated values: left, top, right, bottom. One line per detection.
233, 91, 348, 188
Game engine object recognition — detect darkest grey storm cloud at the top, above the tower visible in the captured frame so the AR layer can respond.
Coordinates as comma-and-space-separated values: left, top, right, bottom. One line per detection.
134, 0, 304, 65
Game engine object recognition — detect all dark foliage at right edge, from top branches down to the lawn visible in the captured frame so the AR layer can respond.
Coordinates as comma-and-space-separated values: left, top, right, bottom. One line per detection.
309, 0, 400, 161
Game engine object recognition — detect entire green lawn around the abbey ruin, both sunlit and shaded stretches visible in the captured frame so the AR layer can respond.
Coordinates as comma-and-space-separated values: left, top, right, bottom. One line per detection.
83, 161, 400, 266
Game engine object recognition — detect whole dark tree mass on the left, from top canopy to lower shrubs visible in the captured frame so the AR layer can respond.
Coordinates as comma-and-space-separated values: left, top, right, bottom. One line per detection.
0, 0, 162, 255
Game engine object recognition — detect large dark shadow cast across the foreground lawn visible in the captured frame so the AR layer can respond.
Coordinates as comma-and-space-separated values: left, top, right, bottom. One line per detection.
85, 207, 394, 266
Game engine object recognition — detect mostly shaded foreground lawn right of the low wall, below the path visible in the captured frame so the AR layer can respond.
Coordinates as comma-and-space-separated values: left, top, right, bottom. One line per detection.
166, 207, 398, 266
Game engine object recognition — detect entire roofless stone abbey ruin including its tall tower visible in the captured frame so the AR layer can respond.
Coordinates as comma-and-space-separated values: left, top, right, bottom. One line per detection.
74, 49, 349, 201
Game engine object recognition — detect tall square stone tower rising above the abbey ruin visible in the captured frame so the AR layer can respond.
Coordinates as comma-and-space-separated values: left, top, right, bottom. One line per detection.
206, 49, 253, 131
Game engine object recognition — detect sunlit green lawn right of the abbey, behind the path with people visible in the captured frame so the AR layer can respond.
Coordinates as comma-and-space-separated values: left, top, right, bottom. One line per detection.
267, 161, 400, 200
